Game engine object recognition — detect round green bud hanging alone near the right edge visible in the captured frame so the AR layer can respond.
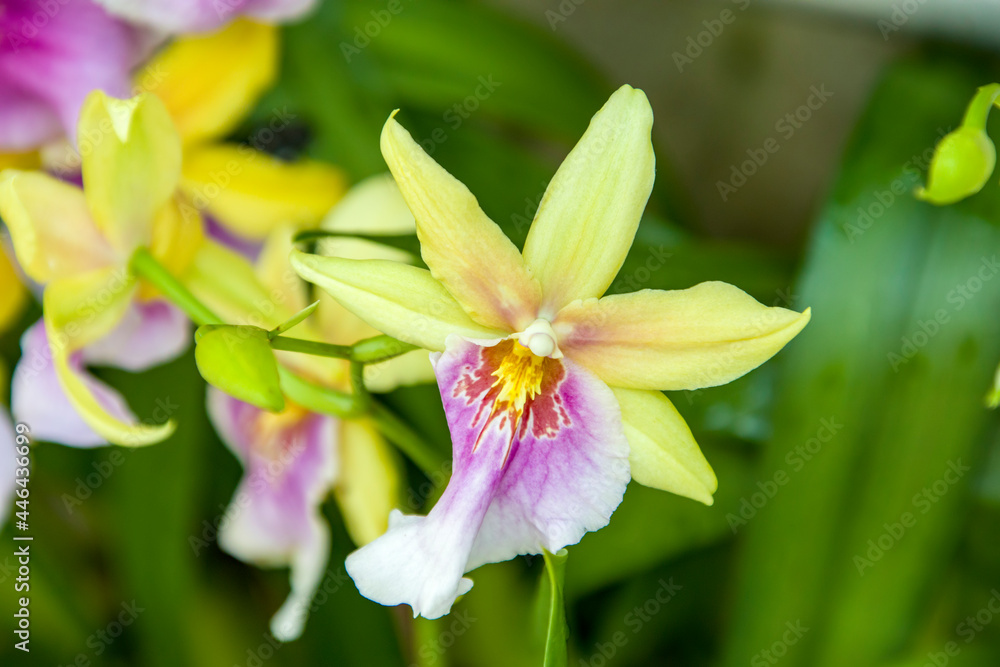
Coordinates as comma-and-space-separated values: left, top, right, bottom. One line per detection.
916, 126, 997, 205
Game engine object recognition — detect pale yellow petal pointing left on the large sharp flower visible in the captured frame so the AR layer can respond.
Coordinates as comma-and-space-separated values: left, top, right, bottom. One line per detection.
291, 251, 505, 351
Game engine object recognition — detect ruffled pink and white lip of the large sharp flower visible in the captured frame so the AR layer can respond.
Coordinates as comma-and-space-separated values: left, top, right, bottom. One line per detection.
347, 336, 629, 618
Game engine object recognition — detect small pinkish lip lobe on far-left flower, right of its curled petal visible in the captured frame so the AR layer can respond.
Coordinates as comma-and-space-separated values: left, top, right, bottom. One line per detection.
83, 301, 193, 372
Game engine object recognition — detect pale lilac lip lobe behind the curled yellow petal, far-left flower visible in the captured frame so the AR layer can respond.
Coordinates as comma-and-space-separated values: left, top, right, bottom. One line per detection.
10, 320, 137, 447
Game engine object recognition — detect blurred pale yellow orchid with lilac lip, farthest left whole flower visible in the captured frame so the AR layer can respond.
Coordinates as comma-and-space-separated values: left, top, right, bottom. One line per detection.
0, 91, 202, 446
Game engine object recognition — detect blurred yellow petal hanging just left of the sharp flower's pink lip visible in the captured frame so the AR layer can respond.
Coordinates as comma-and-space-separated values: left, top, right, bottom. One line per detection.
333, 420, 402, 546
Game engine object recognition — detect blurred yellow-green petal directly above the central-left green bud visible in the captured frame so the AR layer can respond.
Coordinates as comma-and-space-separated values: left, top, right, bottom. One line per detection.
180, 239, 295, 329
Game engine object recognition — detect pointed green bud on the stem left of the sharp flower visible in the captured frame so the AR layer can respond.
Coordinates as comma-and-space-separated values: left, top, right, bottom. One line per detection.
194, 324, 285, 412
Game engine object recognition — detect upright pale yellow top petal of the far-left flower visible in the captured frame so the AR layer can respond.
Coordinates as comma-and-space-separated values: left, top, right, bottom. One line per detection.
78, 90, 181, 254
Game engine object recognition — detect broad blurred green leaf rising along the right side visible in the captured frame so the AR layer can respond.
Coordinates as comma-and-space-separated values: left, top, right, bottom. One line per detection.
721, 57, 1000, 667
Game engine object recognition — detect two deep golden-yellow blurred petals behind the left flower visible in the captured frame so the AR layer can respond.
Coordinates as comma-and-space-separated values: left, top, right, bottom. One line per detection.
136, 20, 346, 243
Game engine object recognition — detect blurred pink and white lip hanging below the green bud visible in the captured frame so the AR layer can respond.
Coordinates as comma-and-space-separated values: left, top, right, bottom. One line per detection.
208, 388, 339, 641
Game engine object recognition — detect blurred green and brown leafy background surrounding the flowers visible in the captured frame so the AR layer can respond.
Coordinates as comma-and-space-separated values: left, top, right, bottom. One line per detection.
0, 0, 1000, 667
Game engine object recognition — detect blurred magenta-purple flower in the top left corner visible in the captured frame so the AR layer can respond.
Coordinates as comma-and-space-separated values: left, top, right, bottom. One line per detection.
0, 0, 146, 151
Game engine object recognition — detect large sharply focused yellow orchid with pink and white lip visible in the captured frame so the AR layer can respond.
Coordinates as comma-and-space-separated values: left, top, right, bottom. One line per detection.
292, 86, 809, 618
